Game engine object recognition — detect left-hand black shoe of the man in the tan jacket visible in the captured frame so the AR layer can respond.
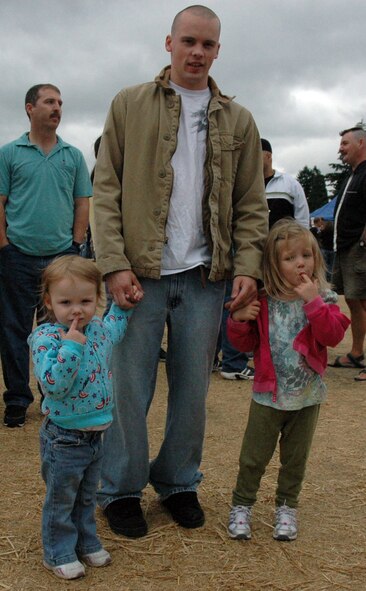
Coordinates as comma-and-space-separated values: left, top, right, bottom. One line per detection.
104, 497, 147, 538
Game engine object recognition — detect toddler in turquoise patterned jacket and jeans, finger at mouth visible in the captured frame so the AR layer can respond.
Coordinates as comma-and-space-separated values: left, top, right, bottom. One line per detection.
28, 256, 138, 579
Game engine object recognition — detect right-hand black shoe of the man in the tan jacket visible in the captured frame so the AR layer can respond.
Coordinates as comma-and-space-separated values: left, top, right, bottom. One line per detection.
162, 491, 205, 529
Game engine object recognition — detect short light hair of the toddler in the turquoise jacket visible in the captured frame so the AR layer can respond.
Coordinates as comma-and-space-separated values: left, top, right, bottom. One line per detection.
41, 255, 102, 322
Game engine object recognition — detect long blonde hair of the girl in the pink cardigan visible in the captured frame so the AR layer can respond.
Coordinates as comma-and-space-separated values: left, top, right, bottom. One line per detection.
263, 218, 329, 299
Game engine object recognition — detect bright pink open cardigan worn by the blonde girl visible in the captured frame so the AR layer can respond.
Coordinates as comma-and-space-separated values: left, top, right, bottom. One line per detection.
227, 296, 351, 402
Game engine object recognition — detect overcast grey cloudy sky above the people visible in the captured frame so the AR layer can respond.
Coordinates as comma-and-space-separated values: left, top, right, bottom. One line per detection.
0, 0, 366, 187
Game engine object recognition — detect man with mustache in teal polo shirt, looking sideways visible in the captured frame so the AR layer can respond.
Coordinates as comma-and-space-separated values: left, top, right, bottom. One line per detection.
0, 84, 92, 427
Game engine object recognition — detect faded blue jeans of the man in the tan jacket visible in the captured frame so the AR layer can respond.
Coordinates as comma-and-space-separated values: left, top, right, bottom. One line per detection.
98, 267, 225, 509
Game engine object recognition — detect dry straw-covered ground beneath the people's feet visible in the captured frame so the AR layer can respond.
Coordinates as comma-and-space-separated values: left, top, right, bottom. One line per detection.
0, 298, 366, 591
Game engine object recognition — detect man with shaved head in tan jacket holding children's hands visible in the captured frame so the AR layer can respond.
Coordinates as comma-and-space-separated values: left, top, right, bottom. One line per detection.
94, 5, 268, 537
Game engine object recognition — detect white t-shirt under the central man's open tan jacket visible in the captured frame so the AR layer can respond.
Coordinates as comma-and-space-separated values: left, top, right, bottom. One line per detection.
161, 82, 211, 275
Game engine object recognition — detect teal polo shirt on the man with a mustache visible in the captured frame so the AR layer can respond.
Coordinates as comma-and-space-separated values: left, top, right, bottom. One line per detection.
0, 133, 92, 256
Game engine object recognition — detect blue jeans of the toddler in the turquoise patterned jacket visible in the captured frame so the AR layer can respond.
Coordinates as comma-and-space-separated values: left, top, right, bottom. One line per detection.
40, 419, 103, 566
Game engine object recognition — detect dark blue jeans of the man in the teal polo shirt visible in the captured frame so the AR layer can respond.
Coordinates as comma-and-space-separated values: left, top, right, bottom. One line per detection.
0, 244, 77, 408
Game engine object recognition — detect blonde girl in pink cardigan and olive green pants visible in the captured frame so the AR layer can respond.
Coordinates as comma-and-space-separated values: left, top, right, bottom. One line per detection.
227, 219, 350, 541
